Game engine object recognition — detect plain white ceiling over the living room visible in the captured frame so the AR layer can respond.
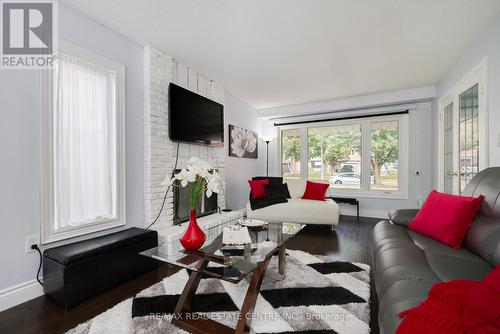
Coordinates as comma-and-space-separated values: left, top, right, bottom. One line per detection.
62, 0, 500, 108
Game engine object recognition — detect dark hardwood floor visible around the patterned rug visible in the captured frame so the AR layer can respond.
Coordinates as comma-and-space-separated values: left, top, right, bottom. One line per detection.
0, 216, 380, 334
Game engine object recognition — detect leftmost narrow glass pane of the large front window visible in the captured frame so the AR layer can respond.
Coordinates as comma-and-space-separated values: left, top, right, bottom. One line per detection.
281, 129, 302, 179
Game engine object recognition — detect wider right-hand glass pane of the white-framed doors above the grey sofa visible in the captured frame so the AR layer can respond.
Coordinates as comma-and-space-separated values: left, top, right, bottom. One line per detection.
458, 84, 479, 193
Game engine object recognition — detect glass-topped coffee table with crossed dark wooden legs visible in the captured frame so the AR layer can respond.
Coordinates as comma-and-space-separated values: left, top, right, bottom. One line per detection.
140, 221, 305, 334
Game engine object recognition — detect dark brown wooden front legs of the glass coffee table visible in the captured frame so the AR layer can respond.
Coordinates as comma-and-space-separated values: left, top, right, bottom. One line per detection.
172, 256, 271, 334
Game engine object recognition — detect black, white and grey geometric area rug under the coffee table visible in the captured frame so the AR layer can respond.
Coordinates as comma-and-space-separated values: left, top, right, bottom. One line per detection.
68, 250, 370, 334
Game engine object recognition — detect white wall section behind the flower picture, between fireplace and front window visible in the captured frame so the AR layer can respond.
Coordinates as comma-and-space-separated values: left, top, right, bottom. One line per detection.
224, 94, 273, 210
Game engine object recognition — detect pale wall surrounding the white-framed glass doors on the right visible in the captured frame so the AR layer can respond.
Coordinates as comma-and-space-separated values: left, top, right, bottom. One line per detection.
432, 10, 500, 187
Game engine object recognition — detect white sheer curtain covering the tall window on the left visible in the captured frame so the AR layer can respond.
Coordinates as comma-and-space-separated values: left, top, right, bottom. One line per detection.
53, 54, 118, 231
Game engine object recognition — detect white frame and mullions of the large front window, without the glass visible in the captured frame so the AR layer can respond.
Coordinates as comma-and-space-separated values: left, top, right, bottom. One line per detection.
275, 114, 410, 199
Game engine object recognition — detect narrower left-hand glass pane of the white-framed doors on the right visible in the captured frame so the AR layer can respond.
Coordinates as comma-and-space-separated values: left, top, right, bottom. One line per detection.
443, 102, 453, 194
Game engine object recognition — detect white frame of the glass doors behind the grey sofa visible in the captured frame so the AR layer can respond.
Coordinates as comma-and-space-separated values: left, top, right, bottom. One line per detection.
438, 57, 489, 194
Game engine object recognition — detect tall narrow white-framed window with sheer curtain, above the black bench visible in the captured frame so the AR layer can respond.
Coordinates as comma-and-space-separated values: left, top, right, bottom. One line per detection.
42, 43, 125, 243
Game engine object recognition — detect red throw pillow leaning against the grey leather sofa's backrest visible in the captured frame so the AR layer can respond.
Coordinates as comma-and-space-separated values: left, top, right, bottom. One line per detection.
408, 190, 484, 249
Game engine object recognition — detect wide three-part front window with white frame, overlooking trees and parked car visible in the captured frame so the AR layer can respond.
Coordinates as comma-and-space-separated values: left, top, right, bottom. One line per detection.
280, 114, 408, 198
